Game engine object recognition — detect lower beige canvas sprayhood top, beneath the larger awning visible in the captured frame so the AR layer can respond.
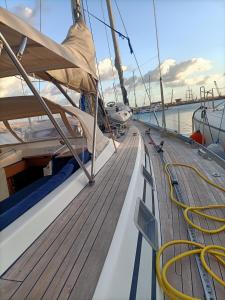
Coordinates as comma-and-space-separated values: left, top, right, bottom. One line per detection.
0, 96, 109, 156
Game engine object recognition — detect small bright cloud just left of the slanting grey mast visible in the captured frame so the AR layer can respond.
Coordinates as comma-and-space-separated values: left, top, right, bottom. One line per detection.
98, 58, 128, 81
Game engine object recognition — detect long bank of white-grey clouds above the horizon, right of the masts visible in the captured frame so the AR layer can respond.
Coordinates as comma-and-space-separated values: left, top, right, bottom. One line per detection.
105, 57, 225, 103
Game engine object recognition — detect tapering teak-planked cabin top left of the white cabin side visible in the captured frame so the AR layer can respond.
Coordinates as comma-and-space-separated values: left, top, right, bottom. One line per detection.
0, 128, 139, 300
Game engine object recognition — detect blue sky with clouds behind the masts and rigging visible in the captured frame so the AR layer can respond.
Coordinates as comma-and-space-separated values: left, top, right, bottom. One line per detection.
0, 0, 225, 106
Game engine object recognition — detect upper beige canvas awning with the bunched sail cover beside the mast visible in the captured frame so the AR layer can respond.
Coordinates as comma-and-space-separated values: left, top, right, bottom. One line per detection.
0, 8, 97, 93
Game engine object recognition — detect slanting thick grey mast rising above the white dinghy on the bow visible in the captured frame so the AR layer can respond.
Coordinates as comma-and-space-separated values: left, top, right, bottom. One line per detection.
106, 0, 129, 105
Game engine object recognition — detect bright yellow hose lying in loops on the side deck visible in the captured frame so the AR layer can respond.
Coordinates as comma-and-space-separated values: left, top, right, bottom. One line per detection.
156, 163, 225, 300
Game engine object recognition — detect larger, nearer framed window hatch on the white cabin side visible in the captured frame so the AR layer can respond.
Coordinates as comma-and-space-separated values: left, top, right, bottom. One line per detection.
134, 198, 158, 250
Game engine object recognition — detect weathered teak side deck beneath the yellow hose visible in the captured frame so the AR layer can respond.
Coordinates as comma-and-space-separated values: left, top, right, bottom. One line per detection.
135, 122, 225, 300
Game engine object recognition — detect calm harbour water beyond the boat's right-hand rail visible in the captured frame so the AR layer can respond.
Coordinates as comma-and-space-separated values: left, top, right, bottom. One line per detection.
133, 100, 224, 136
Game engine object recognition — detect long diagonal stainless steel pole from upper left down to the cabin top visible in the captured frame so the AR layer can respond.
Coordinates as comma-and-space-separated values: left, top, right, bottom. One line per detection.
0, 32, 92, 182
